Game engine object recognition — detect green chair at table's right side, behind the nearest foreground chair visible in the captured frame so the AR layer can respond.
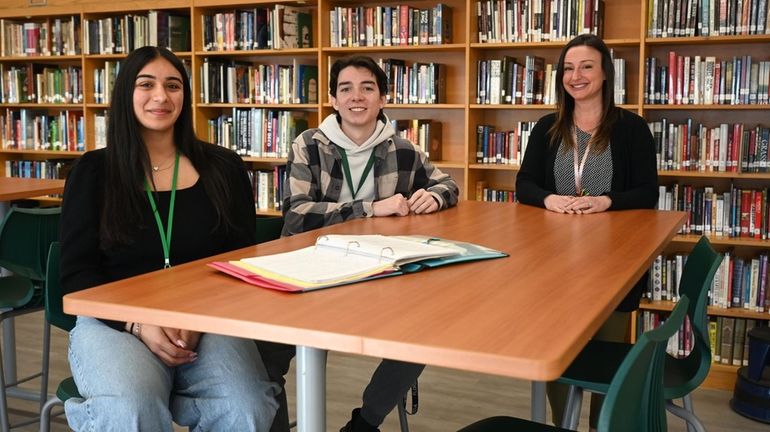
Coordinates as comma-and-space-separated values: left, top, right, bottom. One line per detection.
558, 237, 722, 431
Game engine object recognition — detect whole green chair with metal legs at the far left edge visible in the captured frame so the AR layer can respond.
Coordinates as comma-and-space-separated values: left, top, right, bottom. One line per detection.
0, 207, 61, 431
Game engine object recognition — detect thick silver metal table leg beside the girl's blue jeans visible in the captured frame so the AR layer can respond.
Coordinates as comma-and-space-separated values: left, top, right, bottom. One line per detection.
296, 346, 327, 432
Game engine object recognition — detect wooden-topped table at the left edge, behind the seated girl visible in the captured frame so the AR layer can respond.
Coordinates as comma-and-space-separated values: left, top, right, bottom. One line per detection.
0, 177, 64, 398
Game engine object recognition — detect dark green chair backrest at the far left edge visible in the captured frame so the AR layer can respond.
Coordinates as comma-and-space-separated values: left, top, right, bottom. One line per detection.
0, 207, 61, 283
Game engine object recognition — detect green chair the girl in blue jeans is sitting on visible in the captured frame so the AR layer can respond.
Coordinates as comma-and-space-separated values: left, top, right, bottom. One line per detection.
40, 242, 81, 432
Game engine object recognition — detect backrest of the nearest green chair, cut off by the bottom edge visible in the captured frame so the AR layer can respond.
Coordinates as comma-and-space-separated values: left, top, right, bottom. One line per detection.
597, 296, 690, 432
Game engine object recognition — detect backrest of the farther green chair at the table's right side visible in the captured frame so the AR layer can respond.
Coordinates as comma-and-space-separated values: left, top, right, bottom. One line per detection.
664, 237, 722, 399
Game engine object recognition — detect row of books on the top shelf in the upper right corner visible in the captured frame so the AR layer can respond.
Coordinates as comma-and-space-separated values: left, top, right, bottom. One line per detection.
647, 0, 770, 38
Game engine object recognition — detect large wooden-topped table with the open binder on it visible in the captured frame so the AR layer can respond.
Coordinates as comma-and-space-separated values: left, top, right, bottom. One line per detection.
64, 201, 685, 431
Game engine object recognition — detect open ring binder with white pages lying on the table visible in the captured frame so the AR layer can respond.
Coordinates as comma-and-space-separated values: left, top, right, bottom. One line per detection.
208, 235, 507, 292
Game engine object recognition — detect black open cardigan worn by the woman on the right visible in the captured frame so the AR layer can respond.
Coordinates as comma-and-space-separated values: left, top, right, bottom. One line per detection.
516, 109, 658, 312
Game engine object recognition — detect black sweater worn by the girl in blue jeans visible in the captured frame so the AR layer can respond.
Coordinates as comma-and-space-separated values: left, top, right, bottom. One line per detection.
61, 145, 256, 330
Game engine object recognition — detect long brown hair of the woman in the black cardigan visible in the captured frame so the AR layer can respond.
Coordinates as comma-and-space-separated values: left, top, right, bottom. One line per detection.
548, 34, 620, 153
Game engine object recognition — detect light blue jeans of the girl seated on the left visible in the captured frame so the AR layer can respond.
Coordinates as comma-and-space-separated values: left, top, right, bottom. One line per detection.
65, 317, 280, 432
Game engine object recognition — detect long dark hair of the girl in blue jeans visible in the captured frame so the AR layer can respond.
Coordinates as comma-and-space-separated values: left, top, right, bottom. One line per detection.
99, 46, 237, 247
